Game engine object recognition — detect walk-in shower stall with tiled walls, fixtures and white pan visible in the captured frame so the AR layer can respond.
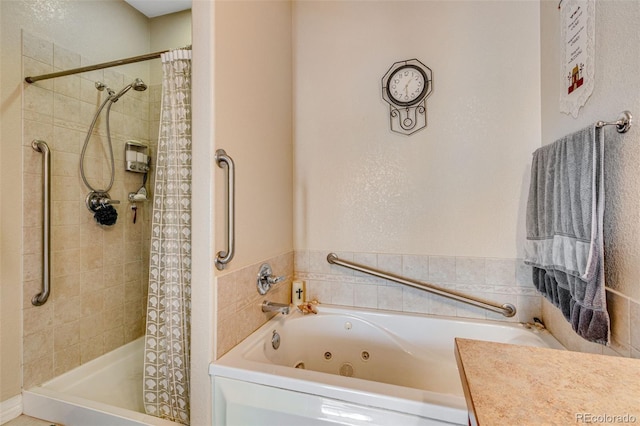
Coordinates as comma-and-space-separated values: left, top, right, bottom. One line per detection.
23, 19, 190, 425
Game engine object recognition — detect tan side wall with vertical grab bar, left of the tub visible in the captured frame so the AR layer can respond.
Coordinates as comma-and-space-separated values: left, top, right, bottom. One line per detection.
208, 1, 293, 416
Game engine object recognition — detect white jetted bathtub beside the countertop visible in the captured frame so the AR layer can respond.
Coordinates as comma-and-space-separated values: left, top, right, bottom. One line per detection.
209, 305, 564, 425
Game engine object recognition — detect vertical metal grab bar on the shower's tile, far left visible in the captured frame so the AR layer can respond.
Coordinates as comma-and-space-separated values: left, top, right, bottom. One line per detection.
31, 139, 51, 306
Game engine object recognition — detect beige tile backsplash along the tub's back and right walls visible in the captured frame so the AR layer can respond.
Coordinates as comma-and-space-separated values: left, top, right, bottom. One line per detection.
295, 250, 640, 358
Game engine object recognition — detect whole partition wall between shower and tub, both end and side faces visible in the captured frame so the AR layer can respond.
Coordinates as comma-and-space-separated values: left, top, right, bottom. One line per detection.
191, 1, 293, 424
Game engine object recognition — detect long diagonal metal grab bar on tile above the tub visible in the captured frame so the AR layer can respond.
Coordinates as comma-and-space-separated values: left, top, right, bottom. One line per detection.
327, 253, 516, 317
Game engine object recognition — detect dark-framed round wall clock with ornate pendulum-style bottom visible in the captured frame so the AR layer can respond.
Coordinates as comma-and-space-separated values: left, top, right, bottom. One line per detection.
382, 59, 433, 135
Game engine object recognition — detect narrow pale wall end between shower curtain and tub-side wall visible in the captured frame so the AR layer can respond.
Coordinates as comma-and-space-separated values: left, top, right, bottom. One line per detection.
186, 0, 216, 425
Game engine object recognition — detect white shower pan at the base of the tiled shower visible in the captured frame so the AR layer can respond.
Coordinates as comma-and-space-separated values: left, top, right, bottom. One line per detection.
22, 337, 178, 426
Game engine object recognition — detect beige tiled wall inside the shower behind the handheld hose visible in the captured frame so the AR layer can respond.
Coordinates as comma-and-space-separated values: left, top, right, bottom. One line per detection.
23, 33, 152, 388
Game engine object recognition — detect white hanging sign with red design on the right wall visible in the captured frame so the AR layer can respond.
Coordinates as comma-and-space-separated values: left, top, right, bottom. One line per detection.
560, 0, 595, 118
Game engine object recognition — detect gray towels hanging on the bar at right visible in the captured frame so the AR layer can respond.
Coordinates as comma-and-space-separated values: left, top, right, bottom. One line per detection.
525, 126, 611, 345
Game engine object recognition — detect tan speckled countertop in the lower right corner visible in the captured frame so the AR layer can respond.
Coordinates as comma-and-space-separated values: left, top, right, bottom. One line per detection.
455, 339, 640, 426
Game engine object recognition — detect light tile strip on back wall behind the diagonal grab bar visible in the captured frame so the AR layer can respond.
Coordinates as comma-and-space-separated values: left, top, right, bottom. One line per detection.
295, 250, 542, 322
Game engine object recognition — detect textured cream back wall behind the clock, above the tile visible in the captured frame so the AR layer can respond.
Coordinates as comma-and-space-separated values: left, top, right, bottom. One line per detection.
294, 1, 540, 258
